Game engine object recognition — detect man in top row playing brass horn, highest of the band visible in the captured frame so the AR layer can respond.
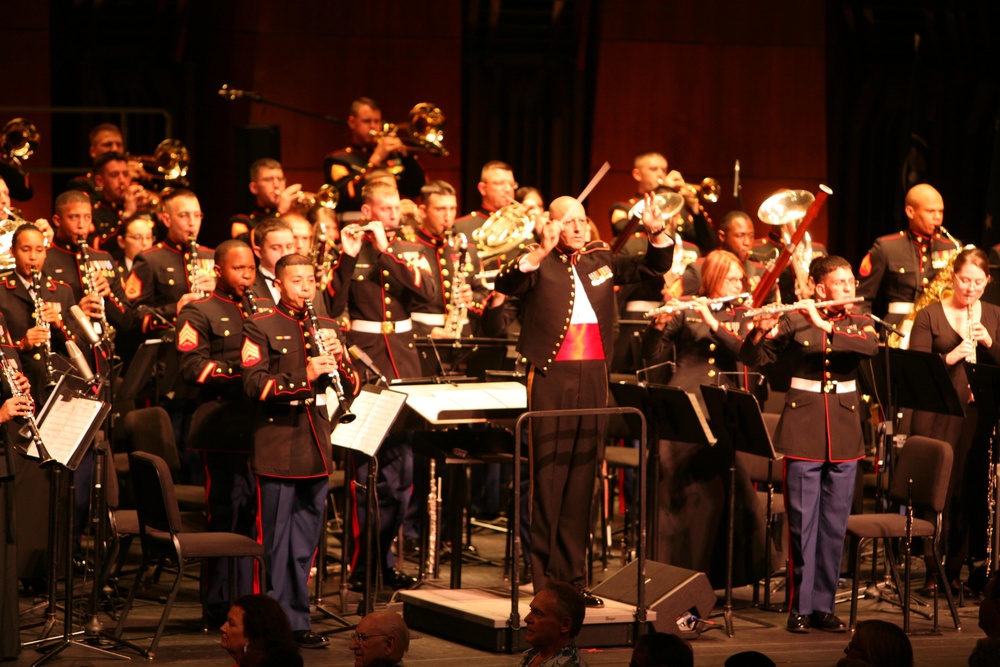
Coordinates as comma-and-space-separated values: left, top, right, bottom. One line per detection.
323, 97, 427, 217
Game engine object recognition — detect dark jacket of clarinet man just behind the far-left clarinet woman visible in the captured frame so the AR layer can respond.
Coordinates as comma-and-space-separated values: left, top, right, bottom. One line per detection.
42, 238, 133, 331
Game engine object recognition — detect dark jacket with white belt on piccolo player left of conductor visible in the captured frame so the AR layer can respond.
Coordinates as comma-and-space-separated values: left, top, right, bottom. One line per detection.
347, 237, 434, 378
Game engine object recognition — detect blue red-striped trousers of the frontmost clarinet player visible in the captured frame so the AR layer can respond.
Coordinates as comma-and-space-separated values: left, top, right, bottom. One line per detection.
257, 475, 330, 632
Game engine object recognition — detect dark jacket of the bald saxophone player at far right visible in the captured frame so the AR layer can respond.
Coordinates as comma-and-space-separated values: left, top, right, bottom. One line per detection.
857, 231, 956, 321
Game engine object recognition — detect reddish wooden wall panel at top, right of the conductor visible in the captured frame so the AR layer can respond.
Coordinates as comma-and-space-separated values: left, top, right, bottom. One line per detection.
589, 0, 827, 245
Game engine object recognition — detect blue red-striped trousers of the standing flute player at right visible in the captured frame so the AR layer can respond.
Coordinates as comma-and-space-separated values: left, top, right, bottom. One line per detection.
785, 458, 858, 614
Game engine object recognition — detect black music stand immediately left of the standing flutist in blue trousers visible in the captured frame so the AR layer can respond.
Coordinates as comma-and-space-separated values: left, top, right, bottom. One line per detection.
701, 384, 778, 637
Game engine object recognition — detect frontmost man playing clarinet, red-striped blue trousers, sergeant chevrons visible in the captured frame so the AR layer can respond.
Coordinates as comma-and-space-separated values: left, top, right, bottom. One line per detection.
240, 254, 360, 648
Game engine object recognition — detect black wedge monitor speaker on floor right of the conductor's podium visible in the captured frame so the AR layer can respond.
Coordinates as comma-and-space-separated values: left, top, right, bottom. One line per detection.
593, 560, 716, 637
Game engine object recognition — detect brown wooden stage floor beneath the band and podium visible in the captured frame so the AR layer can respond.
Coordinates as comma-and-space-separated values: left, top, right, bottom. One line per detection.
6, 516, 984, 667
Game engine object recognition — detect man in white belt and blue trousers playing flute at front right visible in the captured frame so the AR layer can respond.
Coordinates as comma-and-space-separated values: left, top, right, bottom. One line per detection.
740, 255, 878, 632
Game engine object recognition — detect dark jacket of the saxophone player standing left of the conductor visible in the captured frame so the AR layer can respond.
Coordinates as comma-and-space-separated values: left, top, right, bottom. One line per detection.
401, 230, 489, 336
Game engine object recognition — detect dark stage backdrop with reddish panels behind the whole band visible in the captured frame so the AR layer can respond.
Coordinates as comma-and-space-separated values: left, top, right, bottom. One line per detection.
0, 0, 1000, 265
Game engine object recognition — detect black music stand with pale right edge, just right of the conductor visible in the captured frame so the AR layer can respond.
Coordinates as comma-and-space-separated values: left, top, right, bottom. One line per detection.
610, 382, 715, 549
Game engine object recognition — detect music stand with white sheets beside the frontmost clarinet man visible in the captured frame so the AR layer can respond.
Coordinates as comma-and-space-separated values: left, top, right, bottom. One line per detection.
323, 384, 406, 614
